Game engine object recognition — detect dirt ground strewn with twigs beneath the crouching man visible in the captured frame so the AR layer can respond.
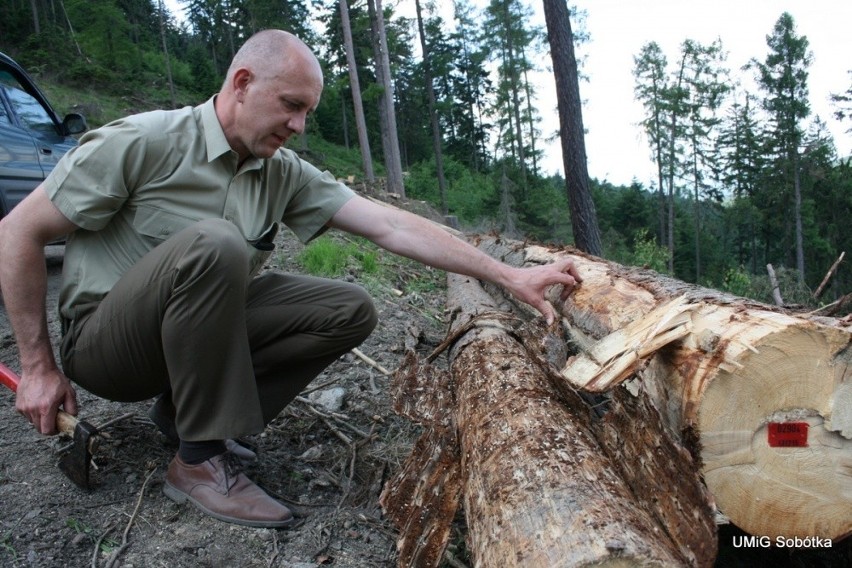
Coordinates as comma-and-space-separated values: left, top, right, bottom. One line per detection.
0, 197, 852, 568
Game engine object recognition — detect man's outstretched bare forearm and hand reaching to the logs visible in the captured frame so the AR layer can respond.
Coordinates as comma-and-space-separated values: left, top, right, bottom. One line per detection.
329, 195, 582, 324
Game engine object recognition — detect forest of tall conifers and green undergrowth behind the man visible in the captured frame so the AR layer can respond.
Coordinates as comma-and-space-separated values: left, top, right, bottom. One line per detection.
0, 0, 852, 311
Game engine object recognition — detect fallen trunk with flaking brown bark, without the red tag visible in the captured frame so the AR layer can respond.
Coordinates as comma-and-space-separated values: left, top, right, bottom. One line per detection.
382, 275, 716, 567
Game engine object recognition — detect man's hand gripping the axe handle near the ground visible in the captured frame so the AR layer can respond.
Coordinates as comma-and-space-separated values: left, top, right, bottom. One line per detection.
15, 369, 77, 434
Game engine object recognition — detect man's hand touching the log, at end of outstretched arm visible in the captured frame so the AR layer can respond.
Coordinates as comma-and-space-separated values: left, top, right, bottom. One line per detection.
502, 258, 583, 325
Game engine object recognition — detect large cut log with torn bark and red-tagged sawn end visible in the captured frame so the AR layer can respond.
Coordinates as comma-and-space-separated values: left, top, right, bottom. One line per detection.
480, 234, 852, 539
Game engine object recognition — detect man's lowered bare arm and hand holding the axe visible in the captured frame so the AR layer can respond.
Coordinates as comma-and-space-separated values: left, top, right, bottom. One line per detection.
0, 186, 77, 434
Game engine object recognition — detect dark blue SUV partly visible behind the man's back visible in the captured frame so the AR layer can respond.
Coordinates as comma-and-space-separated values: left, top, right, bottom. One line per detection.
0, 53, 87, 219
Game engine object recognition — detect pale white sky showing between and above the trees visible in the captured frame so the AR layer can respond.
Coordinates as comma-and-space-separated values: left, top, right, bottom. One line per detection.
166, 0, 852, 187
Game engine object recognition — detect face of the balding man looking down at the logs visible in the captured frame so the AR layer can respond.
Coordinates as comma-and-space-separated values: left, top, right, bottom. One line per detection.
234, 57, 322, 159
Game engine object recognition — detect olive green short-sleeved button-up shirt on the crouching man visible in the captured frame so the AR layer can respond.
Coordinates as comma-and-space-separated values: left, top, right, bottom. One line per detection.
45, 97, 354, 319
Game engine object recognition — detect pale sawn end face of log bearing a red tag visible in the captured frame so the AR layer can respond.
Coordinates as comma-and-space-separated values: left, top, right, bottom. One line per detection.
695, 314, 852, 539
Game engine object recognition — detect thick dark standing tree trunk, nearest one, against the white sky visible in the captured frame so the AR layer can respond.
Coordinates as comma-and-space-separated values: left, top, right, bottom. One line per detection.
544, 0, 603, 256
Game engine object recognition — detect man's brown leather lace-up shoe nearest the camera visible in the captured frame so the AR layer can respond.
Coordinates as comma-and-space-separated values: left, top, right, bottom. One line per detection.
163, 452, 295, 528
